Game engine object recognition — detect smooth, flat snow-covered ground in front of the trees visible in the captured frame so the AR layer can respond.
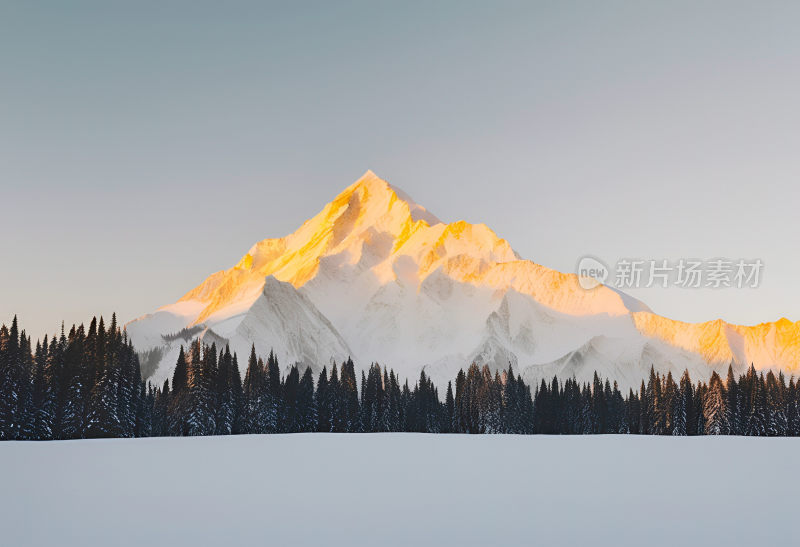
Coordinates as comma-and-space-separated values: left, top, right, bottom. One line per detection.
0, 434, 800, 547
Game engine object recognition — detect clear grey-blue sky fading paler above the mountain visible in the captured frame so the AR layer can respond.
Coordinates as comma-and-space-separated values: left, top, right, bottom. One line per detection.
0, 1, 800, 342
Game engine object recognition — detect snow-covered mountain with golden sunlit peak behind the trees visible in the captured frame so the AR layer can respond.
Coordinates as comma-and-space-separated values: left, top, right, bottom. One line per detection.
127, 171, 800, 388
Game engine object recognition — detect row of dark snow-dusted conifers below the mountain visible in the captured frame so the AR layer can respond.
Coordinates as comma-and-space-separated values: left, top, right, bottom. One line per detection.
0, 317, 800, 440
